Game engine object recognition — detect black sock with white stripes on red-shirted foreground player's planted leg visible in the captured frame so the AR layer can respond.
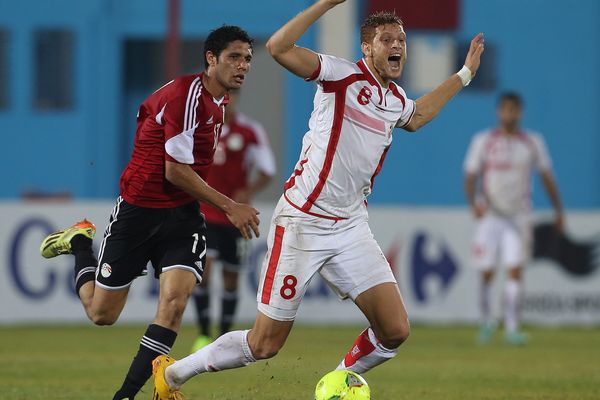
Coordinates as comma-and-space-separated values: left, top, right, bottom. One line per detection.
113, 324, 177, 400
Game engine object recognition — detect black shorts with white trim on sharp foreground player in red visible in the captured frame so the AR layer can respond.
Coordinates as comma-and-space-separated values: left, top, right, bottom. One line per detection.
96, 196, 206, 290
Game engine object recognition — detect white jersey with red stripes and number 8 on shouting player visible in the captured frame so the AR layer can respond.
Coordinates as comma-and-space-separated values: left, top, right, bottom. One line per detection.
284, 54, 415, 219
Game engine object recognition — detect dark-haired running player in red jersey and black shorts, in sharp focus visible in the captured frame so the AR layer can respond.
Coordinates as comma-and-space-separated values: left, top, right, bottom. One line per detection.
40, 26, 259, 400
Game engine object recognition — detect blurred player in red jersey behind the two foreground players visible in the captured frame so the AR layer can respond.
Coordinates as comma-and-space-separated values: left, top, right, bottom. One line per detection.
192, 90, 275, 351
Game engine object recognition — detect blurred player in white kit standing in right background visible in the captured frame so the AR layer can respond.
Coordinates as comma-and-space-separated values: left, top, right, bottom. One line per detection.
464, 93, 563, 345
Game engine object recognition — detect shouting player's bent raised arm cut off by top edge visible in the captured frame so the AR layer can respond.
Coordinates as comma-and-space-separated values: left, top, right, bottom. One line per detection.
266, 0, 345, 78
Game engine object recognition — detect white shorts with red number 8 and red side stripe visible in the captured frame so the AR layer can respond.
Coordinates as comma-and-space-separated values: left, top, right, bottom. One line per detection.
257, 197, 396, 321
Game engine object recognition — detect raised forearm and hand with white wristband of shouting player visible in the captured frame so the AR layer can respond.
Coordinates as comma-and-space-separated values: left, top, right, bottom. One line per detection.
404, 33, 484, 132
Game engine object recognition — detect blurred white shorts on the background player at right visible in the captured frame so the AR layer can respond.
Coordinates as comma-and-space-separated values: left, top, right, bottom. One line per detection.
472, 214, 532, 271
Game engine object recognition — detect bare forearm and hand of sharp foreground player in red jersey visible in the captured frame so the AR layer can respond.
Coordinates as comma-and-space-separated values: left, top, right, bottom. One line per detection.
165, 161, 260, 239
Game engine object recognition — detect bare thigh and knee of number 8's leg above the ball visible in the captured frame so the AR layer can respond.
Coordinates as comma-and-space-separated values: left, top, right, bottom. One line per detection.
355, 282, 410, 348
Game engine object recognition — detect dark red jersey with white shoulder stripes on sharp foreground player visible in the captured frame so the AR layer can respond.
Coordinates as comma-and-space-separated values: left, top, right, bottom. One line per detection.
121, 74, 228, 208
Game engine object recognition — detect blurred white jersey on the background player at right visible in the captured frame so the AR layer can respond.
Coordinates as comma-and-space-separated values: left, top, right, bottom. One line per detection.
464, 129, 552, 216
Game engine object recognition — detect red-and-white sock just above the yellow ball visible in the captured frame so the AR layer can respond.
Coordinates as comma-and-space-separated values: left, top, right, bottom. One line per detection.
336, 328, 398, 374
